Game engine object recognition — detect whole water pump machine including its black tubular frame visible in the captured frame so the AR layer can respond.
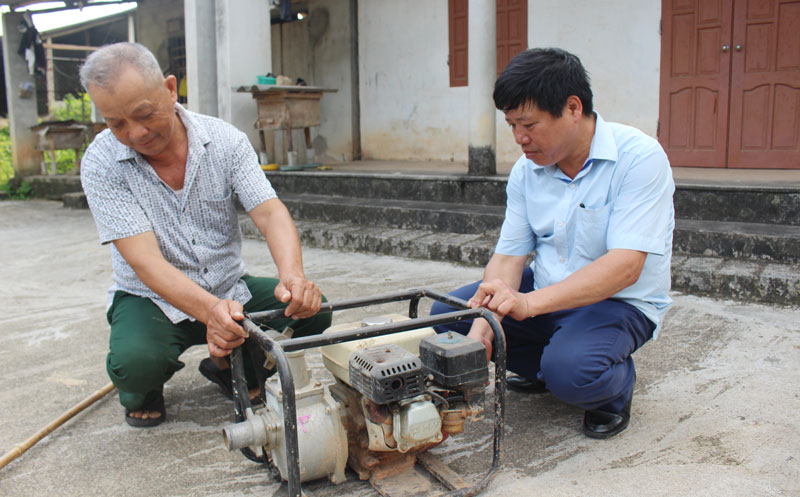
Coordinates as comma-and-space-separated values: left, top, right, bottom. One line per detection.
223, 289, 505, 497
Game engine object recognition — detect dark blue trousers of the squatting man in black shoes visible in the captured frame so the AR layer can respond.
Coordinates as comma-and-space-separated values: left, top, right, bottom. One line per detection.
431, 268, 655, 412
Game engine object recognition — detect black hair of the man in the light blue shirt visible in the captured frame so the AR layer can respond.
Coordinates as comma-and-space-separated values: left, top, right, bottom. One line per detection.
493, 48, 592, 117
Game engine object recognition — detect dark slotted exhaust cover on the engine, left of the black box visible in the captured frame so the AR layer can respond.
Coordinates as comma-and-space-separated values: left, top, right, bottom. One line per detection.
349, 344, 425, 404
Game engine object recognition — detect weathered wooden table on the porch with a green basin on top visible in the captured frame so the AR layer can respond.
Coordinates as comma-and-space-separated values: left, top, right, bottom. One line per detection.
236, 85, 337, 165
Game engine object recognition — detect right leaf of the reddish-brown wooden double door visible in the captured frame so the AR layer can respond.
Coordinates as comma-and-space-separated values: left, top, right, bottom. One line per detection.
728, 0, 800, 169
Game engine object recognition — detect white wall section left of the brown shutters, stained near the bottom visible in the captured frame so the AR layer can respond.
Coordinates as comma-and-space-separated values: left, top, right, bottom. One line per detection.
358, 0, 469, 161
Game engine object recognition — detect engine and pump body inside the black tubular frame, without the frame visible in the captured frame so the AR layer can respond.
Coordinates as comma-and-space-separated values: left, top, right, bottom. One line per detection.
223, 315, 489, 483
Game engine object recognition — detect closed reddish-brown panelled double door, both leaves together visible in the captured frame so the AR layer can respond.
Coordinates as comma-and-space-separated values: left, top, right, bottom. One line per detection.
659, 0, 800, 169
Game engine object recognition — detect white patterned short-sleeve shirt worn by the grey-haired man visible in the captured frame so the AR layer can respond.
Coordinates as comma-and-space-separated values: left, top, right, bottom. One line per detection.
81, 104, 277, 323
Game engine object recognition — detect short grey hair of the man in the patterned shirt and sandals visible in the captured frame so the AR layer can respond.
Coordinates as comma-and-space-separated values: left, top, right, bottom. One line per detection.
80, 42, 164, 91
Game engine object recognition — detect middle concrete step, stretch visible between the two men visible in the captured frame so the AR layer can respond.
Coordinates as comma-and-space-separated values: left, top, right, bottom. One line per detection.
281, 193, 505, 234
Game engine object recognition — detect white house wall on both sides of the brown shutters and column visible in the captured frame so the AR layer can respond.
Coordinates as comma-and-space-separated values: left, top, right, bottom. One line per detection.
359, 0, 661, 165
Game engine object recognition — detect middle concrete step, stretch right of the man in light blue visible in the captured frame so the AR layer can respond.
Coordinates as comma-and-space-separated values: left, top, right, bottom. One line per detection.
672, 219, 800, 264
